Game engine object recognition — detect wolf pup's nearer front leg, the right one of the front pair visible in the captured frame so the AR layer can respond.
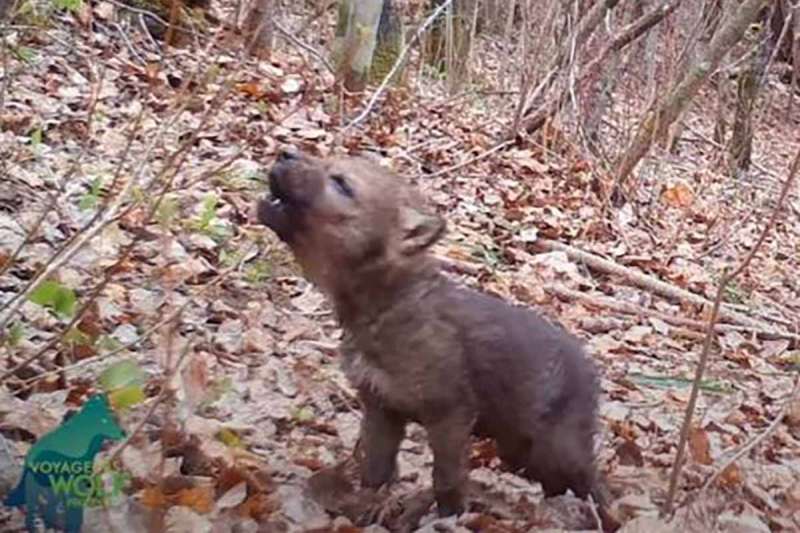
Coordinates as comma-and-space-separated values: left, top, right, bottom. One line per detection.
425, 412, 474, 517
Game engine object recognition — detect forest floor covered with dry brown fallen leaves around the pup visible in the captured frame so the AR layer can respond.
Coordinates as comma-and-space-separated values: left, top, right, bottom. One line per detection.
0, 2, 800, 532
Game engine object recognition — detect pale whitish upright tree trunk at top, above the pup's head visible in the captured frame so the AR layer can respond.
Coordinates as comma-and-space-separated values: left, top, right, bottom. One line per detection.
333, 0, 384, 91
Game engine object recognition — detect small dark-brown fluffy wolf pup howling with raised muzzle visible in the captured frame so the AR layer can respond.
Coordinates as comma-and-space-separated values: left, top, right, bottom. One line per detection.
257, 151, 615, 529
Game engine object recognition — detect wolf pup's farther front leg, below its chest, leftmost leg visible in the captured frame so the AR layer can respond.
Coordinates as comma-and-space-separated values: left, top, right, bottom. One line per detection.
361, 393, 405, 488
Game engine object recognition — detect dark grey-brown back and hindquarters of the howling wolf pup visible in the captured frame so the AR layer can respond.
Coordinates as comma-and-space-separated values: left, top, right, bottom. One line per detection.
442, 288, 597, 497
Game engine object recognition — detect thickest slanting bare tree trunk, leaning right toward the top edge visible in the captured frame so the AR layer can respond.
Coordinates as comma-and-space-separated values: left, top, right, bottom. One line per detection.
615, 0, 768, 192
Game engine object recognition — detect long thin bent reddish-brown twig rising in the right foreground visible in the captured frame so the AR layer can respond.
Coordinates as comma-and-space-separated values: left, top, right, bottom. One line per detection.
664, 143, 800, 515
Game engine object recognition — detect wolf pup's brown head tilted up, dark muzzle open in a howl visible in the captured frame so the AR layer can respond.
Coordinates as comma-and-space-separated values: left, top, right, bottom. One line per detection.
258, 150, 445, 292
